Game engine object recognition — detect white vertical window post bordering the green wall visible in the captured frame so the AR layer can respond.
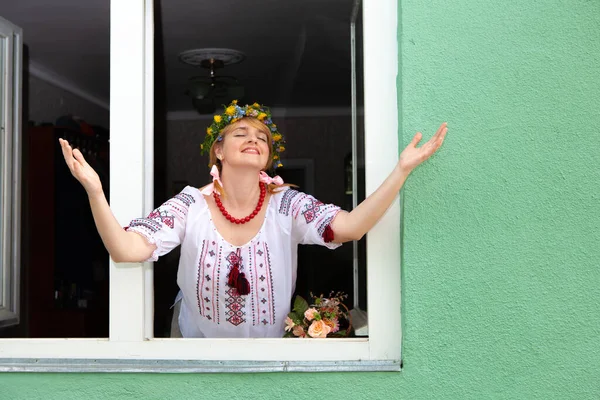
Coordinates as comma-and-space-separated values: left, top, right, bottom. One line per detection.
363, 0, 402, 360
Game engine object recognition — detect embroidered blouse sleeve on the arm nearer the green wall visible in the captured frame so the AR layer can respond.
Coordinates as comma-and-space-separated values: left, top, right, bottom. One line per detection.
279, 189, 341, 249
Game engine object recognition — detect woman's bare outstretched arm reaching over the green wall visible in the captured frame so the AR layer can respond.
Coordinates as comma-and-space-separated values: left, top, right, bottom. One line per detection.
331, 122, 448, 243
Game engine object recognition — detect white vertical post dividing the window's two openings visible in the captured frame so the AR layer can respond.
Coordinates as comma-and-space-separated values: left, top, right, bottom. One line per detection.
109, 0, 147, 340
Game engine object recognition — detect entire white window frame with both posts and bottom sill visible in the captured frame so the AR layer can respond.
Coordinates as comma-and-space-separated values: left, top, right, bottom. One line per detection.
0, 0, 401, 372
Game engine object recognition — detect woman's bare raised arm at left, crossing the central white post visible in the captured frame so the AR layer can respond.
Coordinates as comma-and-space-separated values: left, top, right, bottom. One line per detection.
59, 139, 156, 262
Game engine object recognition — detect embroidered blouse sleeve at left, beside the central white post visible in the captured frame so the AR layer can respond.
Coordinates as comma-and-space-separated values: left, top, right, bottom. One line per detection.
125, 187, 196, 261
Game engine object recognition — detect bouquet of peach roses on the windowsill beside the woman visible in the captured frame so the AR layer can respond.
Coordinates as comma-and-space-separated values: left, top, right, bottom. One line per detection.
283, 292, 352, 338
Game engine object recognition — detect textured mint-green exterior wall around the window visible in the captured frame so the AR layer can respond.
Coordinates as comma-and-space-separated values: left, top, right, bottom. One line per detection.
0, 0, 600, 400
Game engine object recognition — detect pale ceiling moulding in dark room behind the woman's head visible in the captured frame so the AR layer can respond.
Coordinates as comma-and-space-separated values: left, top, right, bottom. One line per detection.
167, 107, 363, 121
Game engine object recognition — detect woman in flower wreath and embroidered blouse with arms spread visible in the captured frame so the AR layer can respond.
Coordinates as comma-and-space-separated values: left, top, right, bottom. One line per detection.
60, 101, 447, 337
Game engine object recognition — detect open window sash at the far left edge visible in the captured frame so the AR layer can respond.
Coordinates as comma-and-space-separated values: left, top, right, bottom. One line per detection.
0, 18, 22, 328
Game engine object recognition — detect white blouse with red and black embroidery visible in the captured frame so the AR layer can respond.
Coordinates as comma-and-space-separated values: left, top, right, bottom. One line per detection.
127, 186, 340, 338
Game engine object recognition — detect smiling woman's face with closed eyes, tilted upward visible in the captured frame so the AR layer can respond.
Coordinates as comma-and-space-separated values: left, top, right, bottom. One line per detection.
217, 120, 269, 170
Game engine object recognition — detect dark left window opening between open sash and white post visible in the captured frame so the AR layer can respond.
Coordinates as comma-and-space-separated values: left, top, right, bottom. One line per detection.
0, 6, 110, 338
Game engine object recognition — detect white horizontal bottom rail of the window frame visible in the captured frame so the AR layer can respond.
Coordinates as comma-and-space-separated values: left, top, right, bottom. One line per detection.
0, 339, 369, 361
